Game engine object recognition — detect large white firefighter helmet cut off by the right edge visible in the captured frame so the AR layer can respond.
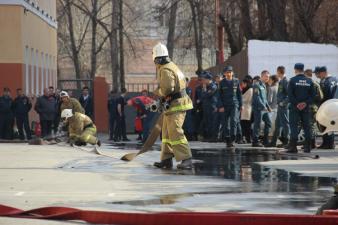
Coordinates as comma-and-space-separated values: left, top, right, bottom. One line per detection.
316, 99, 338, 134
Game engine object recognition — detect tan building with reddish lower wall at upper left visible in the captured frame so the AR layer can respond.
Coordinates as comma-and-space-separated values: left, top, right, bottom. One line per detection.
0, 0, 57, 95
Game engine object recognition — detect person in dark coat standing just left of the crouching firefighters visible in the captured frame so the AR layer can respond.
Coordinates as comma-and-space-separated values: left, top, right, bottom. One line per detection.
34, 88, 57, 138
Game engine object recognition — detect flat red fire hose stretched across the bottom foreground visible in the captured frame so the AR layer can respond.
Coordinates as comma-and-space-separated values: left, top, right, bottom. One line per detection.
0, 205, 338, 225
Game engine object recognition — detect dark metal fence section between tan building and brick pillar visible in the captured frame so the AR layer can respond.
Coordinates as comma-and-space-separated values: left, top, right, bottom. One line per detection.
58, 79, 93, 98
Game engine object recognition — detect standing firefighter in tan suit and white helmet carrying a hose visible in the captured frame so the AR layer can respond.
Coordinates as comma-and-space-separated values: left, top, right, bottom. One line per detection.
153, 43, 193, 169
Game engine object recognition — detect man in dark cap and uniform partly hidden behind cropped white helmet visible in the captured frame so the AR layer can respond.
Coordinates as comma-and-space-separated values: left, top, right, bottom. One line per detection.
317, 66, 338, 149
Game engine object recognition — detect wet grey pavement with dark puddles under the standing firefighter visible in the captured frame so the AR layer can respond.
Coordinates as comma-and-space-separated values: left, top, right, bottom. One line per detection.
0, 137, 338, 224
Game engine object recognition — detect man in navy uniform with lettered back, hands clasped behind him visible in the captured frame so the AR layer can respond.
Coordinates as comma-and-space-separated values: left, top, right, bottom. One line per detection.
287, 63, 316, 153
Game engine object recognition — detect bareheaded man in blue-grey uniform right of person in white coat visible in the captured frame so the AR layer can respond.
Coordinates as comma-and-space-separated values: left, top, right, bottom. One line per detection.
252, 70, 271, 147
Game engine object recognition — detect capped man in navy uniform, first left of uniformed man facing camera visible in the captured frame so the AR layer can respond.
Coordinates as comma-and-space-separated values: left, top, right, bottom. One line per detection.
201, 71, 217, 141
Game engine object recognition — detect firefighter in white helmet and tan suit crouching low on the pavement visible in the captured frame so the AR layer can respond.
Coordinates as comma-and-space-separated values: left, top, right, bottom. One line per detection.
61, 109, 101, 146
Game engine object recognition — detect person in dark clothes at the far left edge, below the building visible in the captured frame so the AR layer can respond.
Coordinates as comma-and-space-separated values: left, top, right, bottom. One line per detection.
0, 88, 14, 140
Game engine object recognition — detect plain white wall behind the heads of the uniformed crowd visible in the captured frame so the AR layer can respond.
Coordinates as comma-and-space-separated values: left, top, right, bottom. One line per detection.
248, 40, 338, 78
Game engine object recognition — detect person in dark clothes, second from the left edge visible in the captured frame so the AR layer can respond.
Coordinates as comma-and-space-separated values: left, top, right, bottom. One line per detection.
13, 88, 32, 140
